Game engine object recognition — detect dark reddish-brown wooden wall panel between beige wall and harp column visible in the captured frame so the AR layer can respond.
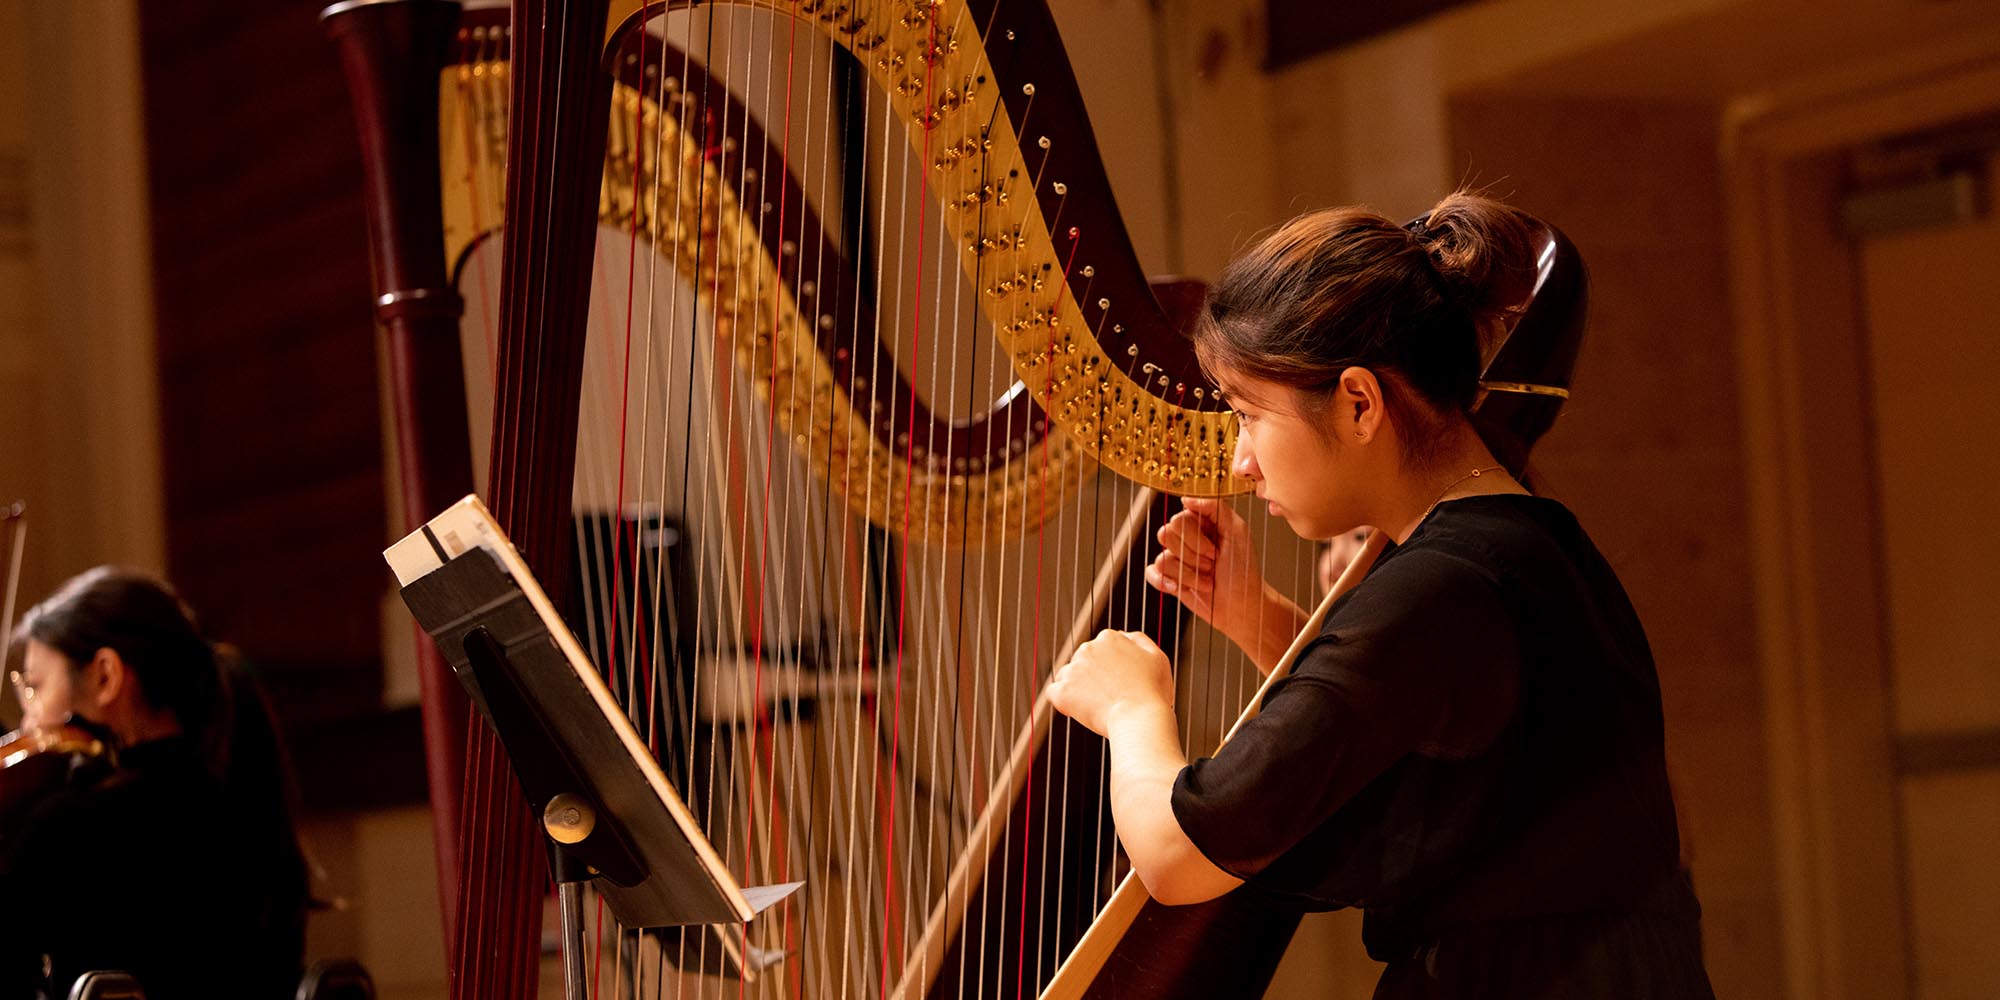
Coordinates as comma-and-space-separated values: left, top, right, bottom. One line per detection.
138, 0, 386, 728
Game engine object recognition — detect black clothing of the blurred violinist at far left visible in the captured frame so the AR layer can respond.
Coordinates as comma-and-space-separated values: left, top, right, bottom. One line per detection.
0, 736, 306, 1000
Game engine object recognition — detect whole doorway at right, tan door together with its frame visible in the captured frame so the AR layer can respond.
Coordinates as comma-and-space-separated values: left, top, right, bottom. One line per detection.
1728, 48, 2000, 1000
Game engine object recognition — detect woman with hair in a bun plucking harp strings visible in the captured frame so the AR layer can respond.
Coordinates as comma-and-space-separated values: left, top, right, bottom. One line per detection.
1050, 194, 1712, 998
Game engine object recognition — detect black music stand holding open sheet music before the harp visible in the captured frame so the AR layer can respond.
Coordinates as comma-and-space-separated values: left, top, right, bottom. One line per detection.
382, 496, 804, 996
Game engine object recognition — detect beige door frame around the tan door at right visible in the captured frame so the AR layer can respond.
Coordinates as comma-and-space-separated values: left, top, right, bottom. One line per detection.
1722, 32, 2000, 1000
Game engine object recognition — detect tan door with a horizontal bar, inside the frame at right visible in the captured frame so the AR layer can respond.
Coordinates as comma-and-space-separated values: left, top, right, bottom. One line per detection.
1858, 158, 2000, 1000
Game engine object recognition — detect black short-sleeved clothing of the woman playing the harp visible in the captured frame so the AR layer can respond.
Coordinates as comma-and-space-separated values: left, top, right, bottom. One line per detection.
1174, 496, 1712, 1000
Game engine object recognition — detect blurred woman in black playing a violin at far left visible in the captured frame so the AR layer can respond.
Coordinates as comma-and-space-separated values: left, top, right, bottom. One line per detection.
0, 566, 306, 1000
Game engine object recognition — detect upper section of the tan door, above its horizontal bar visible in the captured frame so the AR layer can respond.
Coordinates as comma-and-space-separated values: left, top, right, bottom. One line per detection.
1862, 188, 2000, 734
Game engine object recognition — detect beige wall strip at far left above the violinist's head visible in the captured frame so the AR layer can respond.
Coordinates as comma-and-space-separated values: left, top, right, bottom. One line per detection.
0, 0, 164, 624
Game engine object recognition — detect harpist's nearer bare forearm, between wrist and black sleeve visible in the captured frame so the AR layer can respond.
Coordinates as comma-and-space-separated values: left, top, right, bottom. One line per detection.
1106, 704, 1240, 904
